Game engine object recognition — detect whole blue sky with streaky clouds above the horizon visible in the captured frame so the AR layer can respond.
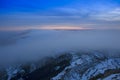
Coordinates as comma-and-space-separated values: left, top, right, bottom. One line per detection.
0, 0, 120, 30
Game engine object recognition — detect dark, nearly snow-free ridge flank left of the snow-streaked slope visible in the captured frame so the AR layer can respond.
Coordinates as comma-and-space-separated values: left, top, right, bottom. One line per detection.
23, 55, 71, 80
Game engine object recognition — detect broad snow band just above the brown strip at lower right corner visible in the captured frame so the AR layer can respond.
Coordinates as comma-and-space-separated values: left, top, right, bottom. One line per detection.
82, 58, 120, 80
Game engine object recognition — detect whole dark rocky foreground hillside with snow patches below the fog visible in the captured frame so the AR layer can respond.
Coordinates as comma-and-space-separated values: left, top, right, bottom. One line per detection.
0, 52, 120, 80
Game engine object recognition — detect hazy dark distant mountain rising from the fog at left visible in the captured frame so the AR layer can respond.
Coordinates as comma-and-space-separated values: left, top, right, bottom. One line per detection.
0, 30, 30, 46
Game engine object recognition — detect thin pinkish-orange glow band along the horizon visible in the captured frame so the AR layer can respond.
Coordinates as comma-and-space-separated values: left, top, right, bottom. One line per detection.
0, 25, 91, 31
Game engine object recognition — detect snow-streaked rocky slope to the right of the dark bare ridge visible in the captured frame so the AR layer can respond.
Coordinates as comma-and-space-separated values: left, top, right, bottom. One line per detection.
52, 52, 120, 80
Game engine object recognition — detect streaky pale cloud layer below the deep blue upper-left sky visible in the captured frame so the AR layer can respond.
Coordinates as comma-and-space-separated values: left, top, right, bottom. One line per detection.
0, 0, 120, 29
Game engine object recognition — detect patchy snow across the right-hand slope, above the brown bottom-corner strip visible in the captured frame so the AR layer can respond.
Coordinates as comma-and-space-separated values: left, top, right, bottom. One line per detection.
52, 53, 120, 80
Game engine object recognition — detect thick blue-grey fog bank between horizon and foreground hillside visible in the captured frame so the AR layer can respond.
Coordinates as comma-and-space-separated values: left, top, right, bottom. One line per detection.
0, 30, 120, 63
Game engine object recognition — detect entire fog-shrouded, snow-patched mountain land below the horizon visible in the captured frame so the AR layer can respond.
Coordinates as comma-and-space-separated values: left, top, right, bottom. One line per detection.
0, 30, 120, 80
